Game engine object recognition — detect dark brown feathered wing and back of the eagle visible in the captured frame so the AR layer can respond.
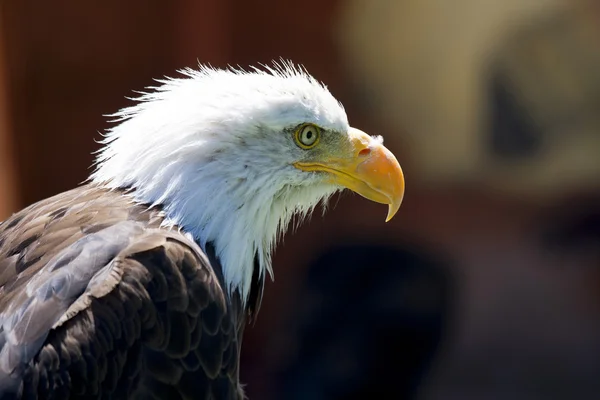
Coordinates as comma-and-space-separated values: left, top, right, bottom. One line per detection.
0, 187, 243, 399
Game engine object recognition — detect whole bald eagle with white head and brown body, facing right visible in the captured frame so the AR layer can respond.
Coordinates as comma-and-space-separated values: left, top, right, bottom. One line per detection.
0, 62, 404, 399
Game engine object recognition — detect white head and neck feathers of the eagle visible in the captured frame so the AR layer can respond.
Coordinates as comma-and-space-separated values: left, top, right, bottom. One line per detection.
91, 63, 349, 301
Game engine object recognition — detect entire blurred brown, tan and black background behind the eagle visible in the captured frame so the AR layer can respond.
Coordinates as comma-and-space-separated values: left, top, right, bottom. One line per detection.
0, 0, 600, 400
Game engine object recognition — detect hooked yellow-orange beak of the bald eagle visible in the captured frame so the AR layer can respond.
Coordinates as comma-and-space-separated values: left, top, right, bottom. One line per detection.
294, 128, 404, 222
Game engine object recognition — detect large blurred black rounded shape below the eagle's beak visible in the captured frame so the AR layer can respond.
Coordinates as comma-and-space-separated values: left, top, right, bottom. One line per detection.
276, 244, 456, 400
